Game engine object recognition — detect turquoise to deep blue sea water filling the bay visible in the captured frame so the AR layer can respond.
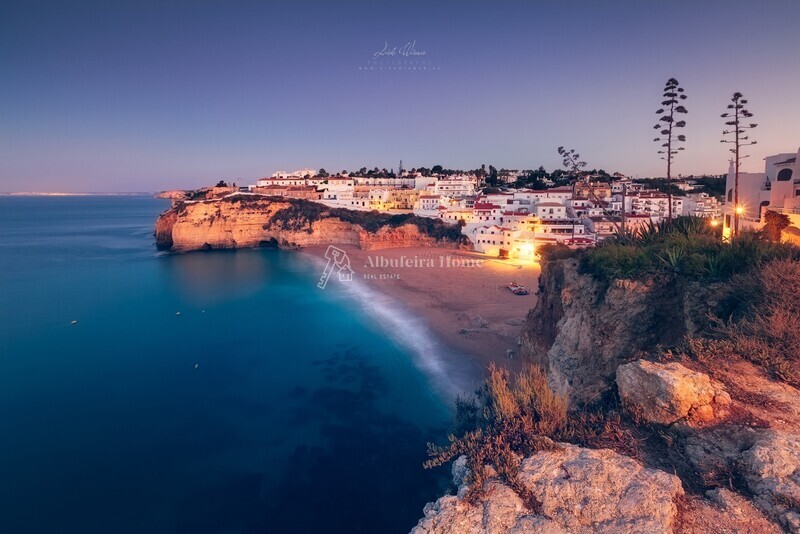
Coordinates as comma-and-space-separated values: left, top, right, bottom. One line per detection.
0, 197, 448, 533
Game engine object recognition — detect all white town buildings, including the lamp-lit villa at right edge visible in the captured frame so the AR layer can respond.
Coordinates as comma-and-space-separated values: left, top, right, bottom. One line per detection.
200, 150, 800, 259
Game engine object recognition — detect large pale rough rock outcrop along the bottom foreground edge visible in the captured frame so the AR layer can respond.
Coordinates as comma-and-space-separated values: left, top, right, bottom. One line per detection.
412, 443, 683, 534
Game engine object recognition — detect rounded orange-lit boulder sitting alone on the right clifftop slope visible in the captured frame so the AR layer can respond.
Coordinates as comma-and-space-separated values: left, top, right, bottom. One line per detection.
617, 360, 731, 425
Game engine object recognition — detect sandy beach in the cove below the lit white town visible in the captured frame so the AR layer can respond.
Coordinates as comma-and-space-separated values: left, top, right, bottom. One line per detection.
303, 246, 539, 376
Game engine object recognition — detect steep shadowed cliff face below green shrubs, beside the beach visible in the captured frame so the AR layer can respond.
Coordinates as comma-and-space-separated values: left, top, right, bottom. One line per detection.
524, 259, 721, 403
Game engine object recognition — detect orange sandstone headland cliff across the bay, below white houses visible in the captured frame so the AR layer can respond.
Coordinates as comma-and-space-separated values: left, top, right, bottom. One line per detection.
155, 195, 464, 252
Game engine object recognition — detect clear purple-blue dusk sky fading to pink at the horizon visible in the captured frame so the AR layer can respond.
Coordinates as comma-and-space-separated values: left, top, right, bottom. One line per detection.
0, 0, 800, 192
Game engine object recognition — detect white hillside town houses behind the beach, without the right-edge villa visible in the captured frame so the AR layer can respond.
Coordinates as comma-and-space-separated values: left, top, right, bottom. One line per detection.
241, 169, 721, 259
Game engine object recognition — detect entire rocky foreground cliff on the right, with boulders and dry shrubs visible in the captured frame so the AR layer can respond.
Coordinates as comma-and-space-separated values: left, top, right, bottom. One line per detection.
413, 252, 800, 533
